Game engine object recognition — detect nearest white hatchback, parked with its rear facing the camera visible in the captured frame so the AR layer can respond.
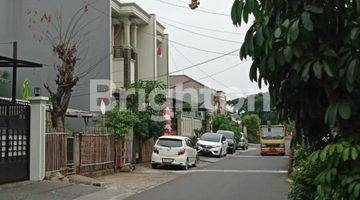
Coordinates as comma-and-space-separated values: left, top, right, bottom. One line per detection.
151, 136, 197, 170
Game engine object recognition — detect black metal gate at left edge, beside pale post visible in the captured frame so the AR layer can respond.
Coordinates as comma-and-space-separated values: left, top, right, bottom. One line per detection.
0, 101, 30, 184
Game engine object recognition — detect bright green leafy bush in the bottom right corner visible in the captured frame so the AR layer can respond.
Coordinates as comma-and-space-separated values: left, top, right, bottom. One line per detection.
308, 141, 360, 200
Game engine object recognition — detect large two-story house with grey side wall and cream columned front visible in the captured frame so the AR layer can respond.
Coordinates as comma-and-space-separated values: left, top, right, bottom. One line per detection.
0, 0, 169, 113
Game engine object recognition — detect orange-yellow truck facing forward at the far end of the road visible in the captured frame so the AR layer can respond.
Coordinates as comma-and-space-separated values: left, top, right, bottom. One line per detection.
260, 125, 285, 156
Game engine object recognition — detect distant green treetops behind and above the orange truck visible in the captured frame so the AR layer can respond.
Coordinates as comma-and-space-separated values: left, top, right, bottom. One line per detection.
228, 93, 280, 125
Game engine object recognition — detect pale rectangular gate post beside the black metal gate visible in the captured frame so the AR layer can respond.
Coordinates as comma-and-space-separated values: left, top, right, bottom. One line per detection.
29, 97, 49, 181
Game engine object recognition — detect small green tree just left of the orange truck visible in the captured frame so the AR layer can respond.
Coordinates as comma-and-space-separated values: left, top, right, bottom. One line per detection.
242, 114, 261, 143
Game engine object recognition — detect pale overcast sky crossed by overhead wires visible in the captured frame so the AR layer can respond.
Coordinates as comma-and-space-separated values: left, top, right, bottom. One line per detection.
125, 0, 266, 99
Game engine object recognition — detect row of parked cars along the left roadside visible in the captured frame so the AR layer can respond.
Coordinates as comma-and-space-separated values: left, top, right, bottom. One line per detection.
151, 130, 248, 170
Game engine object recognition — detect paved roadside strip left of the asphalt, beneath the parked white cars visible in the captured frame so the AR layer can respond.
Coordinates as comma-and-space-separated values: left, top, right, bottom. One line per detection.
0, 157, 219, 200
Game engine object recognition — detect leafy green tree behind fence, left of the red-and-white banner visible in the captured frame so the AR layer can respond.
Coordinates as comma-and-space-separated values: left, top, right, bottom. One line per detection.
126, 81, 166, 138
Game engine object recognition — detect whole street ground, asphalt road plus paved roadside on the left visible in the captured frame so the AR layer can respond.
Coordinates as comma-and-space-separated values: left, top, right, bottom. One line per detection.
0, 143, 289, 200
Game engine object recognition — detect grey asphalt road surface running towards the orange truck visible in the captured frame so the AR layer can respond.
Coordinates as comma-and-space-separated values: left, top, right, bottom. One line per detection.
129, 147, 289, 200
